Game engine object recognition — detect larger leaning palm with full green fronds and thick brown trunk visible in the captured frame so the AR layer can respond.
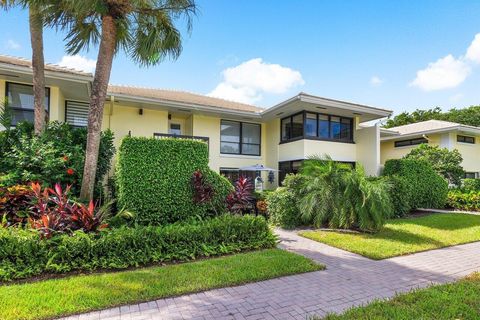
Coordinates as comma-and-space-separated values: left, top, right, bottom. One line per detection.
38, 0, 196, 199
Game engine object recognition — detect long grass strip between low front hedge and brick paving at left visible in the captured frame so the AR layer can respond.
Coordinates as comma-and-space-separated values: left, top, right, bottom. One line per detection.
0, 249, 325, 320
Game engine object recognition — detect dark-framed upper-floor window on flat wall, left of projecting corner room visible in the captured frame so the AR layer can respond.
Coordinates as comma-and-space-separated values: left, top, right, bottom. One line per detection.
220, 120, 261, 156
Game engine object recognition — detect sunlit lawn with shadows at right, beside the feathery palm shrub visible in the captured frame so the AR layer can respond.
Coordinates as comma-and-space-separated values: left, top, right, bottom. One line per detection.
300, 213, 480, 259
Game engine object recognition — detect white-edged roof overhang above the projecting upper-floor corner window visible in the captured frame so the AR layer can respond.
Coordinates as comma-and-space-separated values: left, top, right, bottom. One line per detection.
261, 93, 392, 122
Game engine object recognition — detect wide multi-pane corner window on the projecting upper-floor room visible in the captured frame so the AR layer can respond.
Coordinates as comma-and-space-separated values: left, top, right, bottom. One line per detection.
280, 112, 353, 142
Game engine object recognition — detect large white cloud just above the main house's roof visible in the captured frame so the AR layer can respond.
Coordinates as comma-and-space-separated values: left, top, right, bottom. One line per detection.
208, 58, 305, 103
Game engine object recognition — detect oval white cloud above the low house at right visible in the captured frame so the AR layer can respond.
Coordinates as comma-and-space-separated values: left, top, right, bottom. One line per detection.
410, 54, 471, 91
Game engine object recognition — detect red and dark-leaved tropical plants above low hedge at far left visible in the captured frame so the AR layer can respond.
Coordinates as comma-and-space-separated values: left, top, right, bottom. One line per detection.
0, 183, 107, 238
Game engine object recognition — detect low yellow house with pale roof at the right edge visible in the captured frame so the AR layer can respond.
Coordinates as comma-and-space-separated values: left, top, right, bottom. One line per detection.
380, 120, 480, 178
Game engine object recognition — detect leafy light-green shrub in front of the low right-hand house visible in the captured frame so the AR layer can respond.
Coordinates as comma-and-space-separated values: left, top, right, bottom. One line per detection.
404, 144, 465, 186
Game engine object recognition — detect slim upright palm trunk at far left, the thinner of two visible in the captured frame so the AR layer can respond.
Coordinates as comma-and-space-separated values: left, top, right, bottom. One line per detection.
29, 6, 45, 135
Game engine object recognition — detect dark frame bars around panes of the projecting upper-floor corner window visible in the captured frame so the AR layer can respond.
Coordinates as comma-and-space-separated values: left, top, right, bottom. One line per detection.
280, 110, 355, 144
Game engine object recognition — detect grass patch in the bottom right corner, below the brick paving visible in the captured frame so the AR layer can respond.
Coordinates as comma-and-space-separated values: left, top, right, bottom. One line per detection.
314, 273, 480, 320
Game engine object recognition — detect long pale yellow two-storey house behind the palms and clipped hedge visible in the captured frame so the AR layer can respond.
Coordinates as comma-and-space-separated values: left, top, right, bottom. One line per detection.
0, 56, 392, 188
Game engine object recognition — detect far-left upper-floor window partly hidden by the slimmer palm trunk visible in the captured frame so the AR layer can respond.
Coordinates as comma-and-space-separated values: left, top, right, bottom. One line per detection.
6, 82, 50, 126
